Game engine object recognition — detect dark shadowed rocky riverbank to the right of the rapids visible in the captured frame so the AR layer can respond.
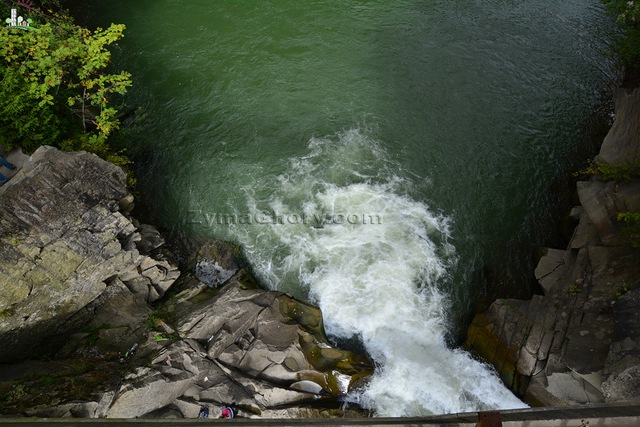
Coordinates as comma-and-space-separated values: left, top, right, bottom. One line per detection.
466, 88, 640, 406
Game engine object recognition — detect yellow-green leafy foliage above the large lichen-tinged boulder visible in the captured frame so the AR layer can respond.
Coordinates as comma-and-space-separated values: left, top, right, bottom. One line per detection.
0, 3, 131, 158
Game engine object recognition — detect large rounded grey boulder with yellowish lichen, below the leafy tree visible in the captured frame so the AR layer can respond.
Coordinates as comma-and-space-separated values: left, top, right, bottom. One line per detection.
0, 147, 180, 363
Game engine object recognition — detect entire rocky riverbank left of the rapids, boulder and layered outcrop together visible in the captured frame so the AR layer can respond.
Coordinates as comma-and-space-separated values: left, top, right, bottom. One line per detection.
0, 147, 373, 418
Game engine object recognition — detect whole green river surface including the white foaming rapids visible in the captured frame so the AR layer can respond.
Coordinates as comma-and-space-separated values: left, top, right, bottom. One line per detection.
71, 0, 612, 416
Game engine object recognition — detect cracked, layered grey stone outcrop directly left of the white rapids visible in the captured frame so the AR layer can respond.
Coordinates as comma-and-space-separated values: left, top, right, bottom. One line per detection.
92, 270, 372, 418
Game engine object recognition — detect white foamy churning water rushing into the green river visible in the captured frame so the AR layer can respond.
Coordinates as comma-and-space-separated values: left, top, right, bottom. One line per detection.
226, 130, 525, 416
